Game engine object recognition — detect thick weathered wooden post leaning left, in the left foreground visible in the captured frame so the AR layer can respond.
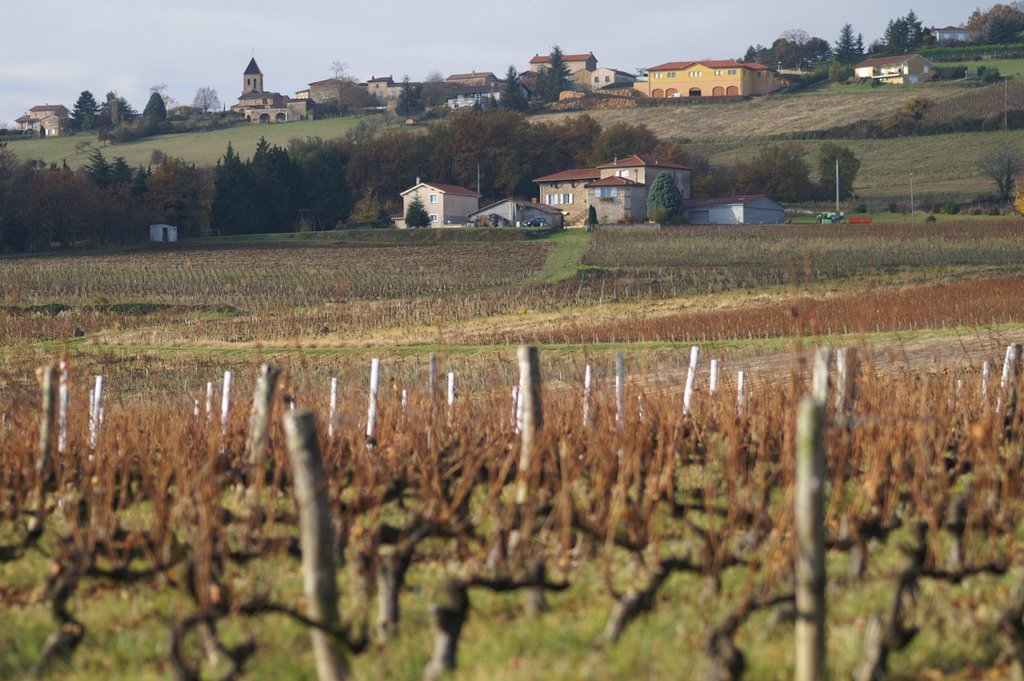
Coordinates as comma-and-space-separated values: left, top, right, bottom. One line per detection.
285, 410, 349, 681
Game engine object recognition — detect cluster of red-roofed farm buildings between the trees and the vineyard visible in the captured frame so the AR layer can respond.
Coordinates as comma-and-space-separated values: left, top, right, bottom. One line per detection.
395, 155, 785, 227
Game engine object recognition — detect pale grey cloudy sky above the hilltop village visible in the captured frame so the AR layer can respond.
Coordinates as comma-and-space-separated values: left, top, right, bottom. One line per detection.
0, 0, 974, 127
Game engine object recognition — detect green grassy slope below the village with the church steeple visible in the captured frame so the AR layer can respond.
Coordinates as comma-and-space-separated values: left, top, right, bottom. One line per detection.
9, 117, 372, 168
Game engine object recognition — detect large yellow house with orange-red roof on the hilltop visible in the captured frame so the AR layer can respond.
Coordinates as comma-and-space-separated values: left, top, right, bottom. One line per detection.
633, 59, 782, 99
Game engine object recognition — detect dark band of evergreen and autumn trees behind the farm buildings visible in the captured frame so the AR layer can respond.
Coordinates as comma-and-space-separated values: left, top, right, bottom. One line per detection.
0, 109, 859, 252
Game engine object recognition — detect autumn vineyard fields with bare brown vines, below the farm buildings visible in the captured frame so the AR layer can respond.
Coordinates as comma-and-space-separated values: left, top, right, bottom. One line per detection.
0, 220, 1024, 680
